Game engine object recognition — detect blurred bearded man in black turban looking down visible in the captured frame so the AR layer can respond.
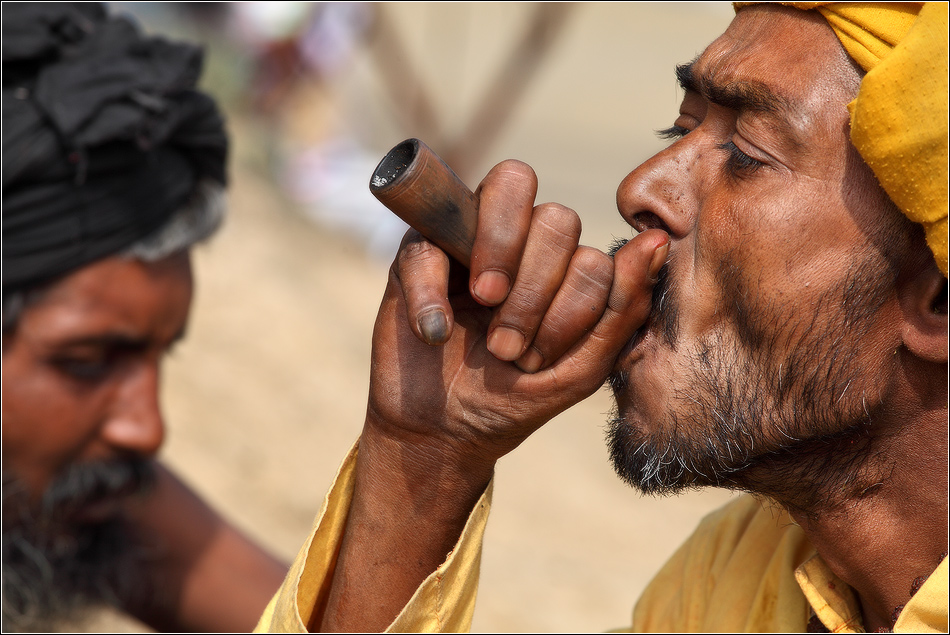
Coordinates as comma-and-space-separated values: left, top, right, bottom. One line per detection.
2, 3, 286, 631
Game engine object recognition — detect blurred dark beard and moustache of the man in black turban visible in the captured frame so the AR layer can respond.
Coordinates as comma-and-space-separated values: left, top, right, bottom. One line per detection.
3, 459, 154, 631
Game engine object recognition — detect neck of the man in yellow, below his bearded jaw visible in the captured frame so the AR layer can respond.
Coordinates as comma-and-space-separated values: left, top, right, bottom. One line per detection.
743, 378, 948, 631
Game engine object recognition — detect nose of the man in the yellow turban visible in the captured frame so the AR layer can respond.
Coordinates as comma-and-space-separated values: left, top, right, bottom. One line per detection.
617, 138, 702, 239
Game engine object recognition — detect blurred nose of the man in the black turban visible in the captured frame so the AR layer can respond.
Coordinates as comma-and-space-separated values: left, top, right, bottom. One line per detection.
101, 362, 165, 457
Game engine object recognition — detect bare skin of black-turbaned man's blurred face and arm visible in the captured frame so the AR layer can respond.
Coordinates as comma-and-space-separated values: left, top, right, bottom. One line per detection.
3, 253, 287, 631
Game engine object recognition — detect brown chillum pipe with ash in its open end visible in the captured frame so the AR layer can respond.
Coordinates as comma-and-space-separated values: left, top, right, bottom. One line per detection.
369, 139, 478, 267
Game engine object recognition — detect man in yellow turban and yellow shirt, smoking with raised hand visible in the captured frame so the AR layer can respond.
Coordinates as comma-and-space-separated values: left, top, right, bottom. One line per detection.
260, 3, 948, 633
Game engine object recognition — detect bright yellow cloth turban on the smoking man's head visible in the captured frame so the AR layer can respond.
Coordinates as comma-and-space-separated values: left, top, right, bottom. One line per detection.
735, 2, 948, 276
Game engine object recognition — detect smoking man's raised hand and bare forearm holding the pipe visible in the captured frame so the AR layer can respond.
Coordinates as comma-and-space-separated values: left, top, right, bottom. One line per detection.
308, 162, 669, 631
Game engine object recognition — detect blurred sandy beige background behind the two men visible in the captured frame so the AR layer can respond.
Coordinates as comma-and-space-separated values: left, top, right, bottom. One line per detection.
91, 2, 733, 632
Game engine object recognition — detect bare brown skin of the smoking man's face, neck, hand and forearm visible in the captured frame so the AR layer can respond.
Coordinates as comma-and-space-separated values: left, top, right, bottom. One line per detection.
309, 5, 947, 631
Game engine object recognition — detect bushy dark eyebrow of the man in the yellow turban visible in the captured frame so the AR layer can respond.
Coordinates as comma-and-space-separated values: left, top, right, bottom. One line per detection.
676, 60, 802, 145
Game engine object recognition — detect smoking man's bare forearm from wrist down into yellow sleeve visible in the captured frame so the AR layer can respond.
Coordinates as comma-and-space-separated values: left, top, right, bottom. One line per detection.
320, 422, 493, 632
